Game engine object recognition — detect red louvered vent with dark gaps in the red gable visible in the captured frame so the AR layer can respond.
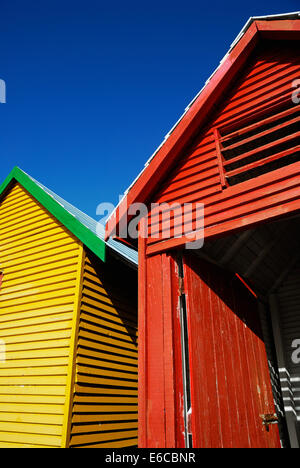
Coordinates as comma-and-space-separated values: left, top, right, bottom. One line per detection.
215, 100, 300, 187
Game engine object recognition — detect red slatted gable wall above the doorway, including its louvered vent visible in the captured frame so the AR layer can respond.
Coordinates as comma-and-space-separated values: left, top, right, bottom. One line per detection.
147, 41, 300, 253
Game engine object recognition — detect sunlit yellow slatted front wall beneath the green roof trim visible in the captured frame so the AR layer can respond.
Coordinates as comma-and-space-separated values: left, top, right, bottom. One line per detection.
0, 184, 82, 447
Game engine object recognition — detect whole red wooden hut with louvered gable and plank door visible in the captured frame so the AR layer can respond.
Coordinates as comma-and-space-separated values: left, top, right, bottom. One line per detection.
107, 12, 300, 448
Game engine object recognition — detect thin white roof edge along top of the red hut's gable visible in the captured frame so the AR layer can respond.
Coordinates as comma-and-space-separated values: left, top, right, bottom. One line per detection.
107, 11, 300, 228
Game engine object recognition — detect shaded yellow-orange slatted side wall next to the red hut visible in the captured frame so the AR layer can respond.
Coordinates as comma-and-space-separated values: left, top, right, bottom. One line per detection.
70, 253, 138, 448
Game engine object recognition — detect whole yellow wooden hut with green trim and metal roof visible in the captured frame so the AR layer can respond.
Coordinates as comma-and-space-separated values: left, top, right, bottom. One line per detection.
0, 168, 137, 448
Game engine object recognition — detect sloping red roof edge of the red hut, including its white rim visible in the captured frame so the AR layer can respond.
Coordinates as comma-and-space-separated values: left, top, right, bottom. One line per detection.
105, 11, 300, 239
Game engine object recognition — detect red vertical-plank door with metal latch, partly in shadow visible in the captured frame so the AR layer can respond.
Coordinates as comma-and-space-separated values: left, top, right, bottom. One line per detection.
184, 255, 280, 448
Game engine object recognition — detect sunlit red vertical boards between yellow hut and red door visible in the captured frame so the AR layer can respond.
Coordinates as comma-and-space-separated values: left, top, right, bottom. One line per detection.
138, 229, 184, 448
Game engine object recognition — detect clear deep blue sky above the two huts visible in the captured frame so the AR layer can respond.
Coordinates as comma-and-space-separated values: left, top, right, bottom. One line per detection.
0, 0, 299, 217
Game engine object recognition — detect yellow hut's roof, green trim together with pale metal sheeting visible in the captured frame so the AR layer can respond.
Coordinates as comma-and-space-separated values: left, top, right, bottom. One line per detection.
0, 167, 138, 266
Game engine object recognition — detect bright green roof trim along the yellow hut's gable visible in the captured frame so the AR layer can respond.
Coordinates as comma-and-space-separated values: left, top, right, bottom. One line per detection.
0, 167, 106, 262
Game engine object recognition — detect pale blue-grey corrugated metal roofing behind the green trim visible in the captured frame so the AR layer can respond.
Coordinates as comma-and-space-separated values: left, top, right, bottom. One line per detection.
23, 171, 138, 266
